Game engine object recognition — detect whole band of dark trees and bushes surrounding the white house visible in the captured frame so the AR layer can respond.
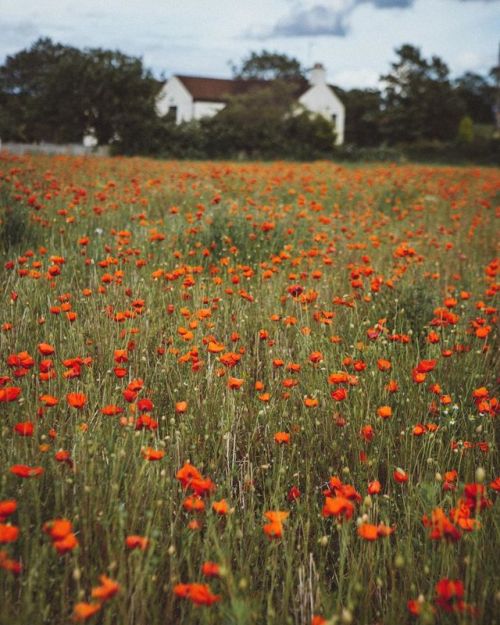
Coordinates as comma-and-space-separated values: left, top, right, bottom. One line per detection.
0, 38, 500, 162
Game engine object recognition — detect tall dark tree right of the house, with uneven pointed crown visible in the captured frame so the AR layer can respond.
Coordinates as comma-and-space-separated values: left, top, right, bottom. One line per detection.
381, 44, 464, 143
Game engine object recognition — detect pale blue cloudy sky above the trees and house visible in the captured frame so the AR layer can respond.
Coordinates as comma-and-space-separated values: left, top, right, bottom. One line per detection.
0, 0, 500, 89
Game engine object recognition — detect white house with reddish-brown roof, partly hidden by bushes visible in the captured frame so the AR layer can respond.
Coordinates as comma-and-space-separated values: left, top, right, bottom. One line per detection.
157, 63, 345, 145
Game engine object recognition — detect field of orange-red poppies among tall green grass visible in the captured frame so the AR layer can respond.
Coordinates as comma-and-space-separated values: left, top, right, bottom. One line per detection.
0, 154, 500, 625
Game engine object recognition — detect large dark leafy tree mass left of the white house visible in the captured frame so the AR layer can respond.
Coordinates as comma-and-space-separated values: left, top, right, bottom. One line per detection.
0, 38, 161, 152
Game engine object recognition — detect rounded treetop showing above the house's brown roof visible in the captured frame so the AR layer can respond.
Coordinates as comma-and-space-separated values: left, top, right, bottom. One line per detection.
231, 50, 305, 80
